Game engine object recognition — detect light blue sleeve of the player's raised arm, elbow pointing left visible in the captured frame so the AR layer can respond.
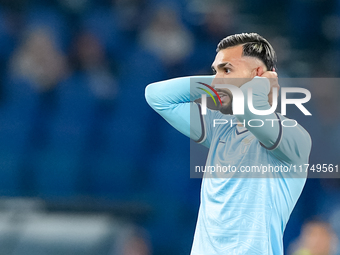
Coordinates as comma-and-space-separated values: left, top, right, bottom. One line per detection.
145, 76, 213, 147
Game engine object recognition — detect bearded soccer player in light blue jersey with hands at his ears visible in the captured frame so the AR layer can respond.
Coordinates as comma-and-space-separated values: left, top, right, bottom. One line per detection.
145, 33, 311, 255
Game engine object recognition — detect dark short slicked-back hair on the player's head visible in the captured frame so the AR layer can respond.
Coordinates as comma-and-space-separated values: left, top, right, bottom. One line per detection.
216, 33, 276, 71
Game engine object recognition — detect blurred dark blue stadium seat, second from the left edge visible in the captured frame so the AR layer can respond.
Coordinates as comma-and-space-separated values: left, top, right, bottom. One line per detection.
33, 75, 93, 196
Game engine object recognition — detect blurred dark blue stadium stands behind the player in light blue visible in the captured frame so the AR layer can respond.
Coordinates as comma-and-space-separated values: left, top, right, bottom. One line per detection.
0, 0, 340, 255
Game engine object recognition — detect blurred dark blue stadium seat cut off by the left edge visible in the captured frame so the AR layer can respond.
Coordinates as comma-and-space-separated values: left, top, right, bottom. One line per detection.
0, 77, 38, 194
